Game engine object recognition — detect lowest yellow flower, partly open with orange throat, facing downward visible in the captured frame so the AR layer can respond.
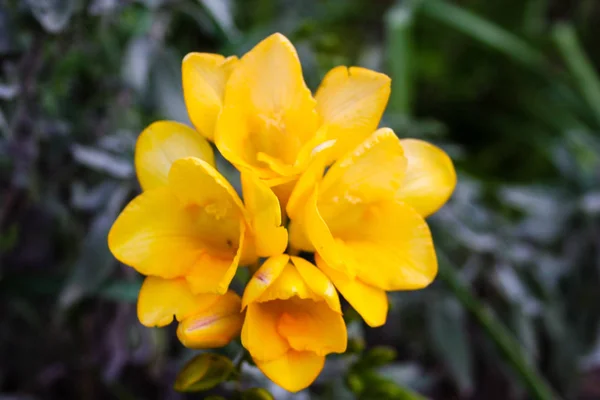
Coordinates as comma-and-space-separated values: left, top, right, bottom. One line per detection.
242, 254, 347, 392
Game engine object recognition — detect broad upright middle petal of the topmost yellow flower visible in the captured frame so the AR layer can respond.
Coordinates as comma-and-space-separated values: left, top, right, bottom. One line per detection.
216, 34, 318, 179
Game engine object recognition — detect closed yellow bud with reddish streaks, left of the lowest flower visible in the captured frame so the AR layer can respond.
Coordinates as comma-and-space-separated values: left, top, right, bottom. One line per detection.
177, 291, 244, 349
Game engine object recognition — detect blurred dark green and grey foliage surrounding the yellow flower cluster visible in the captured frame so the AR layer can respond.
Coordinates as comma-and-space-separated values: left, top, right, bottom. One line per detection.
0, 0, 600, 400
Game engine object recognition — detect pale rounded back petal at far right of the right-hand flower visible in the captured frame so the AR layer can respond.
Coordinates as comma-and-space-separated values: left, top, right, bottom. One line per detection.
397, 139, 456, 217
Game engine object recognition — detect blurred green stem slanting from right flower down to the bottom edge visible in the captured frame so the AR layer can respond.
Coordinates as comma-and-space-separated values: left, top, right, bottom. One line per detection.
438, 250, 560, 400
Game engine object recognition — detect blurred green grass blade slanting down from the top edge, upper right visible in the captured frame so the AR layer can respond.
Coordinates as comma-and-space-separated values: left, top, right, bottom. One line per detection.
421, 0, 545, 71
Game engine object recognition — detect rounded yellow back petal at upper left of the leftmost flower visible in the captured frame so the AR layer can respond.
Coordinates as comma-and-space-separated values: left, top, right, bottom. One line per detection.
135, 121, 215, 190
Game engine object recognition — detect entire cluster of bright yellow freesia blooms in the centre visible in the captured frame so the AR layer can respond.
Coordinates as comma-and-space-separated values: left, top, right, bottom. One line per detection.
108, 34, 456, 391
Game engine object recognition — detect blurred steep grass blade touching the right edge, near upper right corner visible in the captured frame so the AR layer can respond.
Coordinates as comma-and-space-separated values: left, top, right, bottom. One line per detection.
552, 23, 600, 124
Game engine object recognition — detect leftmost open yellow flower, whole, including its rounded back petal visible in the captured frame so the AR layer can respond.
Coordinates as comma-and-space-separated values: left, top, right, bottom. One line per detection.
108, 121, 287, 294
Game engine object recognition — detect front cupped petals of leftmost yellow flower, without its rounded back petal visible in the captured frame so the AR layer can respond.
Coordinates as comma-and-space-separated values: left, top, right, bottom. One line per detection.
108, 157, 247, 294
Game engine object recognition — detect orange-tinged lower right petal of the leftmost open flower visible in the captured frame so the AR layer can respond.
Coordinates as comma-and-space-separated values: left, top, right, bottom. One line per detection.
185, 221, 246, 294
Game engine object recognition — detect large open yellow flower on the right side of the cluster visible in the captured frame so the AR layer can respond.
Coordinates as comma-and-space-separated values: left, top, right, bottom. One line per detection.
287, 128, 456, 326
